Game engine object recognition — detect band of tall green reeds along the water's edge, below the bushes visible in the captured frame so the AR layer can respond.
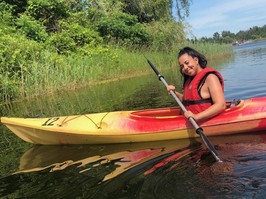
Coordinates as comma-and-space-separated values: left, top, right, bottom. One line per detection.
0, 43, 232, 102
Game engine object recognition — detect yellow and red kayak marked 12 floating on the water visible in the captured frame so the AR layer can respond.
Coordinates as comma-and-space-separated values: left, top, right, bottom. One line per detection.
1, 97, 266, 145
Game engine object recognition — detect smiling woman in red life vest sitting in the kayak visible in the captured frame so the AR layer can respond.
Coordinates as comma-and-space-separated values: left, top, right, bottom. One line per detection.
167, 47, 226, 121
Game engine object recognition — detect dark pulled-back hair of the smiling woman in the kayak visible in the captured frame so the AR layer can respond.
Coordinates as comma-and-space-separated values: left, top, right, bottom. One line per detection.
178, 47, 207, 86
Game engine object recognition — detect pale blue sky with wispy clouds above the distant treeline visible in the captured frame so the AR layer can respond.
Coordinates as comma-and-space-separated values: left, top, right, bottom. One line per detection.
185, 0, 266, 38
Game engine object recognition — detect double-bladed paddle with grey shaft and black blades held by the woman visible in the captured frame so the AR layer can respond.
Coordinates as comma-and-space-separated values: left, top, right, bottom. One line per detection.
146, 58, 222, 162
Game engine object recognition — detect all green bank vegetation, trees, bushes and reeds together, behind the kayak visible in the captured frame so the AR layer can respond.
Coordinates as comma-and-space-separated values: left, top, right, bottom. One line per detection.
0, 0, 231, 103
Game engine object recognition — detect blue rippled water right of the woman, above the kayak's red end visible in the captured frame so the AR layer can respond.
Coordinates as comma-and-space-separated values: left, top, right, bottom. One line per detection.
221, 41, 266, 99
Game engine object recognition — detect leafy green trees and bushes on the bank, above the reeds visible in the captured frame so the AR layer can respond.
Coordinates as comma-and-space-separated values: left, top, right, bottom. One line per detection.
0, 0, 189, 99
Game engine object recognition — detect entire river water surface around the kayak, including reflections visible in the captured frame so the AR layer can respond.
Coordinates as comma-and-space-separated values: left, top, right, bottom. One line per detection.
0, 41, 266, 199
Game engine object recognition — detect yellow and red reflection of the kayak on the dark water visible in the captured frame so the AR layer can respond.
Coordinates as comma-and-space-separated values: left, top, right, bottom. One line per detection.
15, 132, 265, 182
